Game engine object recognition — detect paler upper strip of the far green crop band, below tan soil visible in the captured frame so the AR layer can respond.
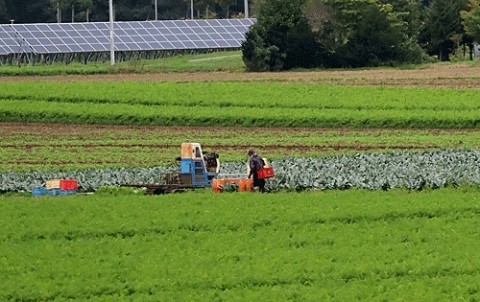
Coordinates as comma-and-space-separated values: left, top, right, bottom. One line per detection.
0, 81, 480, 111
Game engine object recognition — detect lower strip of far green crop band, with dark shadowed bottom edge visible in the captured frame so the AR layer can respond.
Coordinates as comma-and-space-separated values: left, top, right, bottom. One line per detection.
0, 100, 480, 128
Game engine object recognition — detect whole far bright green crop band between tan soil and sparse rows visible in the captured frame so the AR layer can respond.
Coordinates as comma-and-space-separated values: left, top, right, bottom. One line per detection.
0, 81, 480, 128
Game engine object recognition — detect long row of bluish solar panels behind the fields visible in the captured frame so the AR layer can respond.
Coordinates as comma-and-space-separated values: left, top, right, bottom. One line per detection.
0, 19, 255, 55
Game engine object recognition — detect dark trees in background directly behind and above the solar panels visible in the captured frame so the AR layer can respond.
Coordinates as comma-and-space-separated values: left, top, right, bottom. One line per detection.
0, 0, 256, 23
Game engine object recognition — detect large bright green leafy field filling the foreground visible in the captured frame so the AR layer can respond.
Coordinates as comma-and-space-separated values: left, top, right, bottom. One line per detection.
0, 188, 480, 301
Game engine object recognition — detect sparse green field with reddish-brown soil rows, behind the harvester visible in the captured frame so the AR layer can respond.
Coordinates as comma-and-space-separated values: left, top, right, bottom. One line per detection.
0, 123, 480, 172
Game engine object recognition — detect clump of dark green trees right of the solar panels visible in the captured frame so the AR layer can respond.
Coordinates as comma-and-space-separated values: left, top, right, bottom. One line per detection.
242, 0, 480, 71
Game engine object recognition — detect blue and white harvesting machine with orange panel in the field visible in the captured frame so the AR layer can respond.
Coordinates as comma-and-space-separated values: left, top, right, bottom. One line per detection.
125, 143, 224, 194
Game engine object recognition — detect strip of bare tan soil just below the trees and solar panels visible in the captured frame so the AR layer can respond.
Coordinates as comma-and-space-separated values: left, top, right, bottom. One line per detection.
1, 63, 480, 88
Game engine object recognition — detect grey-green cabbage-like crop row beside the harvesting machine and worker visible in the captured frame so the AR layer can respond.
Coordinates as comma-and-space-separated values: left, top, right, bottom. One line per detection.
0, 149, 480, 191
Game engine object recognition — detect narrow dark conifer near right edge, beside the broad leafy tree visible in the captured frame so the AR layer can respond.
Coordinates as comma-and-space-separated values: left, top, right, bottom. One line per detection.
420, 0, 467, 61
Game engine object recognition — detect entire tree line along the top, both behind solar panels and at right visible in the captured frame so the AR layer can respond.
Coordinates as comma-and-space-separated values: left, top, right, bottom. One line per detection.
0, 0, 480, 71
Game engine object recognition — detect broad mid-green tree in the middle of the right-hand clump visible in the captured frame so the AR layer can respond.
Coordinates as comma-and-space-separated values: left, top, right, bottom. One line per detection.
316, 0, 422, 67
